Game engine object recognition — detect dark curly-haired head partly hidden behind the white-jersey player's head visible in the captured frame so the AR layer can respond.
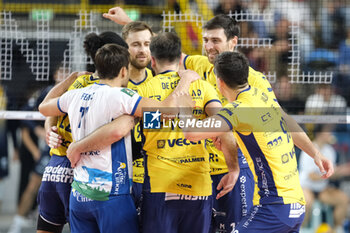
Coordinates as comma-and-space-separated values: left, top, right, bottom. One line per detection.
84, 31, 128, 72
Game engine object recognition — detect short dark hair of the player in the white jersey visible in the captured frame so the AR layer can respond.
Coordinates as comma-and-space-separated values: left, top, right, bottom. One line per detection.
95, 44, 129, 79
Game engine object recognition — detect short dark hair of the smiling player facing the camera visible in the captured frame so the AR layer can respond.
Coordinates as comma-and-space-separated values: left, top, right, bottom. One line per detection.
203, 14, 240, 40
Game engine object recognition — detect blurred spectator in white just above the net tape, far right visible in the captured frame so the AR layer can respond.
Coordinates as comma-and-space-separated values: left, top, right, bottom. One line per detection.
305, 84, 347, 115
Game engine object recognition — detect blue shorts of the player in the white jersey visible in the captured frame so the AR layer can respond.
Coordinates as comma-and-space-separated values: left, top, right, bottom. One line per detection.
69, 189, 139, 233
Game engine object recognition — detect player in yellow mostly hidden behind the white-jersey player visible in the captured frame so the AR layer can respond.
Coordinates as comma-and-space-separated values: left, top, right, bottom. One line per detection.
37, 32, 127, 233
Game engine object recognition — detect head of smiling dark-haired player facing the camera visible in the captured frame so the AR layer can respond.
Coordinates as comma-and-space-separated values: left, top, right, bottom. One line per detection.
203, 15, 239, 63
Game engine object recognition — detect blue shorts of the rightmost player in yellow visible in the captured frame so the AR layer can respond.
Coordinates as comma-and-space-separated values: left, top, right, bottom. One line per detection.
232, 203, 305, 233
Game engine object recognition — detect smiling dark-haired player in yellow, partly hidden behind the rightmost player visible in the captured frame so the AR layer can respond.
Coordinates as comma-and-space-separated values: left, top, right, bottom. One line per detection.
183, 15, 334, 230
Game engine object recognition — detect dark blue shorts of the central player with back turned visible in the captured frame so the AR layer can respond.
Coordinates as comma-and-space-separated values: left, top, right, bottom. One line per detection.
141, 192, 212, 233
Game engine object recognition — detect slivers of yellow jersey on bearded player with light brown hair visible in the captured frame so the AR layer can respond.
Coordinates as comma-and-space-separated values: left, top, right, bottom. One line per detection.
128, 68, 153, 183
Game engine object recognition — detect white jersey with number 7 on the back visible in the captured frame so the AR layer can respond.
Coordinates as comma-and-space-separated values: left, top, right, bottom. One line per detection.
57, 84, 141, 200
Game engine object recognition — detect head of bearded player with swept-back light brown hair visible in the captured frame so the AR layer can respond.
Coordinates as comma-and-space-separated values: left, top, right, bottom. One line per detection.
122, 21, 153, 69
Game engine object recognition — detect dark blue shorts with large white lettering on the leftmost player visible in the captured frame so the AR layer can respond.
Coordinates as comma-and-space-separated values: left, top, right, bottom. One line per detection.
38, 155, 73, 225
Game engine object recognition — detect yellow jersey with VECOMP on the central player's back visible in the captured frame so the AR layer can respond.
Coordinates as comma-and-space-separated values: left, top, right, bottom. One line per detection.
138, 71, 220, 196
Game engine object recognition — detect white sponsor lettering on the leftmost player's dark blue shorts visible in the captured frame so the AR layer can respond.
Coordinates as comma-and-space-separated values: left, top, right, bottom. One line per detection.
42, 165, 73, 183
